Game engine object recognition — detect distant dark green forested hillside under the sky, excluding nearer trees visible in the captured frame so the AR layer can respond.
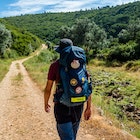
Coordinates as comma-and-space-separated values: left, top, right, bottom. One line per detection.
4, 1, 140, 42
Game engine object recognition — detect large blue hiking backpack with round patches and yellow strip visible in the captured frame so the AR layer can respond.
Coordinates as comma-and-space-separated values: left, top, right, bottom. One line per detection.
55, 46, 92, 106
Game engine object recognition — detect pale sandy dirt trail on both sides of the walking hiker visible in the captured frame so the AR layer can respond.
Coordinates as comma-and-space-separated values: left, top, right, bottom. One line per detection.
0, 56, 138, 140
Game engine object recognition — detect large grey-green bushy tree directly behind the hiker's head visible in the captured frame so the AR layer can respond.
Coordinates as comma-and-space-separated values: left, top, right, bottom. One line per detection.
59, 18, 108, 60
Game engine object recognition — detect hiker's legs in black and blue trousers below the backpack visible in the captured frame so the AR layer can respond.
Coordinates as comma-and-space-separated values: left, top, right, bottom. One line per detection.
54, 103, 83, 140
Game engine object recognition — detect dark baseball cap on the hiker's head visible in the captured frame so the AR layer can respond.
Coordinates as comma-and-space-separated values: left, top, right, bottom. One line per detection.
55, 38, 73, 53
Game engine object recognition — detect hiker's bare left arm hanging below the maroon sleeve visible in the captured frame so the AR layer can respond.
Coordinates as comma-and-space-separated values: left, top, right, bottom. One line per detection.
44, 80, 53, 112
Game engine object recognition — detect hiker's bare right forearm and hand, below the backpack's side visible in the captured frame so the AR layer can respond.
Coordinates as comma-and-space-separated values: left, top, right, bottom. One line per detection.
84, 95, 91, 120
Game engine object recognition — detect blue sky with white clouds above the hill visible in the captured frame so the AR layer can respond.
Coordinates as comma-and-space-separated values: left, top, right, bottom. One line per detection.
0, 0, 140, 18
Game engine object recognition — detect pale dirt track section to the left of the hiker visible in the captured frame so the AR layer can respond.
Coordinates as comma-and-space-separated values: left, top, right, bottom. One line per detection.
0, 60, 58, 140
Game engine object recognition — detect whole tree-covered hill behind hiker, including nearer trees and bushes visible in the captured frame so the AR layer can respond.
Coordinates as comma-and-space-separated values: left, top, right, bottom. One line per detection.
1, 2, 140, 62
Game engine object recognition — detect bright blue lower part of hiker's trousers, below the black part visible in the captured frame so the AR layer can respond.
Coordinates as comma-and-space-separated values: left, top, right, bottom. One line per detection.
57, 122, 77, 140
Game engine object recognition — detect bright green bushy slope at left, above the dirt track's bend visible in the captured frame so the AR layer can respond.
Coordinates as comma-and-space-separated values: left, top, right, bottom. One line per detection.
0, 19, 43, 58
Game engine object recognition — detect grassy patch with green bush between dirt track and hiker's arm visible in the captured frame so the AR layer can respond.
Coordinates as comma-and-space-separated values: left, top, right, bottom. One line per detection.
24, 50, 57, 90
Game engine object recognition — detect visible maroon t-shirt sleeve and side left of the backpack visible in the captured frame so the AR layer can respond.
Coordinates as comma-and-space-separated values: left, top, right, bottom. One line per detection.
48, 60, 60, 83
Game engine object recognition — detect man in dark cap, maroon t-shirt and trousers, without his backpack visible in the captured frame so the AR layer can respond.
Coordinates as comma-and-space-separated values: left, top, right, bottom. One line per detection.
44, 38, 91, 140
